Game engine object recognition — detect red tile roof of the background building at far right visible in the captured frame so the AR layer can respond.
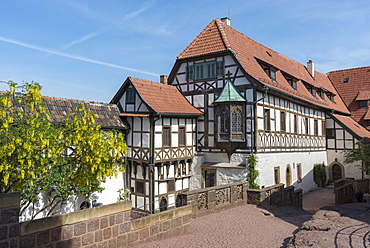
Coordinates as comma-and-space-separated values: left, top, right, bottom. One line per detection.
328, 66, 370, 125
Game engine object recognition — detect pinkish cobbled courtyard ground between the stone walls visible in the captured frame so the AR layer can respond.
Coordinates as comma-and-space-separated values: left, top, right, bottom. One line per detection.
137, 187, 334, 248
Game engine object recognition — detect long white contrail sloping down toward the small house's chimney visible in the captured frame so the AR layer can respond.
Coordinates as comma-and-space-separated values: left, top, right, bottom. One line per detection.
0, 36, 159, 77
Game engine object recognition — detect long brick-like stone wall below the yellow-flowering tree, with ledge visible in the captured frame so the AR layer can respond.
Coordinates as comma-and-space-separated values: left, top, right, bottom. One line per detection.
0, 194, 191, 248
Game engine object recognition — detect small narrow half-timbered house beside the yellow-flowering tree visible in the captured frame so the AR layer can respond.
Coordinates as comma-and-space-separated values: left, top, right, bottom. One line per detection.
111, 76, 202, 211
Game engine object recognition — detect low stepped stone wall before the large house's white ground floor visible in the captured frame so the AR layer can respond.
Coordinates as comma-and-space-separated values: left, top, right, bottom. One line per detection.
248, 183, 303, 207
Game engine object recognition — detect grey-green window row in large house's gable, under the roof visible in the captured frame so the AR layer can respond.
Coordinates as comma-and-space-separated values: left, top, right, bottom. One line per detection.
186, 61, 225, 80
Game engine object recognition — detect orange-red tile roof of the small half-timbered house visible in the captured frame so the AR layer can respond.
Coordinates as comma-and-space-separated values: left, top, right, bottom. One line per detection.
129, 77, 203, 115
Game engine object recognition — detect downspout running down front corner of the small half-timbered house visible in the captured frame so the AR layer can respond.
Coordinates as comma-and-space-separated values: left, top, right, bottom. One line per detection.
149, 115, 161, 214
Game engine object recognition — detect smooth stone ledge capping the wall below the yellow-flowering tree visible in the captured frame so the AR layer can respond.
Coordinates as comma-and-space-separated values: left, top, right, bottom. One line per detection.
21, 201, 132, 236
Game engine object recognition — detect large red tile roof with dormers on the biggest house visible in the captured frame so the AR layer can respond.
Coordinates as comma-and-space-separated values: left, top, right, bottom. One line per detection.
177, 19, 349, 114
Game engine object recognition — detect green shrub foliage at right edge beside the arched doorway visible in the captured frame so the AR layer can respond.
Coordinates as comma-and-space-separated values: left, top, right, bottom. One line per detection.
344, 139, 370, 174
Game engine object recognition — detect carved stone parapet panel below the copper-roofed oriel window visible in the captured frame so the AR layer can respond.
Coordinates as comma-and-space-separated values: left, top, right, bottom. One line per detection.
183, 182, 249, 216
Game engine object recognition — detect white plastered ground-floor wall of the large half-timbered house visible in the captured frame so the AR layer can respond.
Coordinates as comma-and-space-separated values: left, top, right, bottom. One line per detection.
256, 151, 327, 193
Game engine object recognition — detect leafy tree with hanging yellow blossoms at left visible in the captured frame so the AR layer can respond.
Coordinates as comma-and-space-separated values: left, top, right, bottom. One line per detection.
0, 83, 127, 218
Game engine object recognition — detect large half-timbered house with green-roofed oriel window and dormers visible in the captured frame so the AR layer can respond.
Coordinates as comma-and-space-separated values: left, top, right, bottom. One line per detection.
168, 18, 368, 192
